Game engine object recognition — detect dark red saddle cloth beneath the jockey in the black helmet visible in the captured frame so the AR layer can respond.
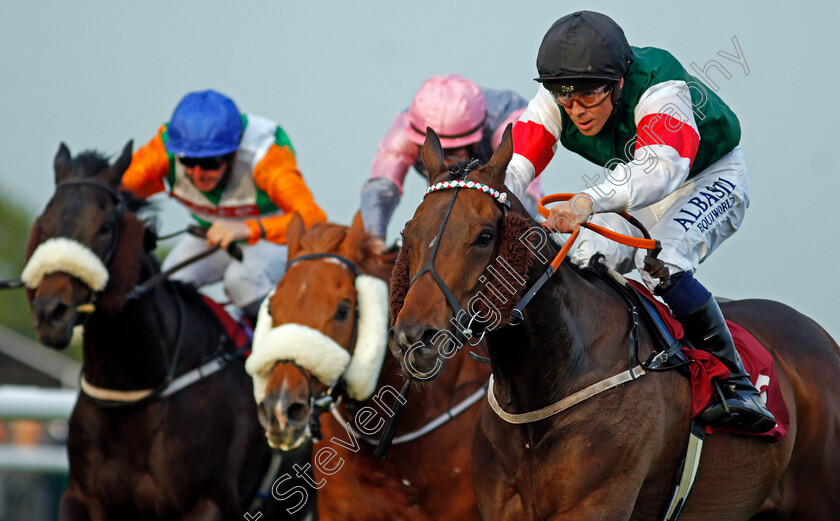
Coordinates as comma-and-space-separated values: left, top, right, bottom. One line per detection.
628, 280, 790, 441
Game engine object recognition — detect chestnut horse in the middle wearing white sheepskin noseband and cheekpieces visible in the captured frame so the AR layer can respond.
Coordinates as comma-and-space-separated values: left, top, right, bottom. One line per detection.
246, 213, 489, 521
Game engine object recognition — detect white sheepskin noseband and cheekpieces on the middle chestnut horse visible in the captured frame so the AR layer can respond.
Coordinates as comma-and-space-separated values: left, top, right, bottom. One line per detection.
245, 275, 388, 403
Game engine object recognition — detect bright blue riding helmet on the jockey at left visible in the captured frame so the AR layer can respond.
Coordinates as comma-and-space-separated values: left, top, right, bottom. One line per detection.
166, 90, 242, 157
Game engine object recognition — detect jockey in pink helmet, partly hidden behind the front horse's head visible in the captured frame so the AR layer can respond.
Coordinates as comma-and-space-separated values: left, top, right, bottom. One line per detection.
362, 74, 542, 248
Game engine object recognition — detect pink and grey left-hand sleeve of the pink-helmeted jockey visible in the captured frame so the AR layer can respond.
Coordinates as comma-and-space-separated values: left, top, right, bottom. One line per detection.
361, 113, 420, 239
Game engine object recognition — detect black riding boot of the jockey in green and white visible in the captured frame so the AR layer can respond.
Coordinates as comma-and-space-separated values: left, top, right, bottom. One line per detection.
677, 297, 776, 434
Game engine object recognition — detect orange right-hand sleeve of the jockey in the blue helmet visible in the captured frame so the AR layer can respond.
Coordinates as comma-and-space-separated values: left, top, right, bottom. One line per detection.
245, 144, 327, 244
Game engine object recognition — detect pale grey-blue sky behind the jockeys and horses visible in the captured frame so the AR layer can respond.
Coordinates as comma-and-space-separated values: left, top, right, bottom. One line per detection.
0, 0, 840, 338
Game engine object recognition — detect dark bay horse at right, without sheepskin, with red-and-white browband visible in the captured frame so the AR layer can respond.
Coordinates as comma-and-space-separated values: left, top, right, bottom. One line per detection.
391, 129, 840, 521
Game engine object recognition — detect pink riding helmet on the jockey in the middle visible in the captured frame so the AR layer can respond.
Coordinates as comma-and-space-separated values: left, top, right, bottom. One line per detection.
408, 74, 487, 148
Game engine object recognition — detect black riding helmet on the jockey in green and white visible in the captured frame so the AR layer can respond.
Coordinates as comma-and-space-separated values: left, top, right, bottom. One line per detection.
534, 11, 633, 119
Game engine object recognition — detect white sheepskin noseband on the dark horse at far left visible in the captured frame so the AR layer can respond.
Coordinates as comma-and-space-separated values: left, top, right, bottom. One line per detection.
20, 237, 108, 291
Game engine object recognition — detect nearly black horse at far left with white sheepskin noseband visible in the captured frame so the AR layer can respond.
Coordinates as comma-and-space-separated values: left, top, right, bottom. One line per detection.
24, 143, 310, 521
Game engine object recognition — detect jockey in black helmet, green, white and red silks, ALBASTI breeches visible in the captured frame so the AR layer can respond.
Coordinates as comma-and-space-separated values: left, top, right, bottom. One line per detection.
505, 11, 775, 432
